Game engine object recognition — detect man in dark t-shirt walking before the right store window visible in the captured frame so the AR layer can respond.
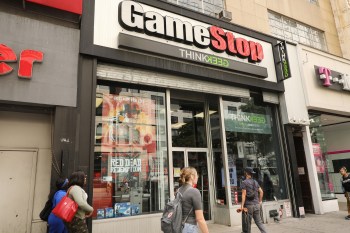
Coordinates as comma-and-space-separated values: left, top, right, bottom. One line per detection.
241, 167, 266, 233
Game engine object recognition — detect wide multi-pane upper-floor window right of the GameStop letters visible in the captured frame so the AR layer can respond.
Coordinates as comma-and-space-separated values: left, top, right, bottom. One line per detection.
269, 11, 327, 51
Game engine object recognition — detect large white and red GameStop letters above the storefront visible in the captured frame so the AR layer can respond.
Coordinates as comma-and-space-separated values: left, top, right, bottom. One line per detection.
118, 1, 264, 63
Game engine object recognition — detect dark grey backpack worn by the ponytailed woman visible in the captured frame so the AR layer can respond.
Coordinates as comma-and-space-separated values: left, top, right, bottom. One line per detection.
160, 188, 193, 233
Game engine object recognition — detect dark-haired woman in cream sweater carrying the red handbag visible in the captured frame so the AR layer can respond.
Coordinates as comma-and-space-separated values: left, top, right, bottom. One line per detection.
66, 171, 94, 233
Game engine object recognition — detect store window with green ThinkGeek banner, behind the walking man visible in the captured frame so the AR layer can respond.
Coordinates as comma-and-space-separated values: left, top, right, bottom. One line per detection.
222, 94, 287, 205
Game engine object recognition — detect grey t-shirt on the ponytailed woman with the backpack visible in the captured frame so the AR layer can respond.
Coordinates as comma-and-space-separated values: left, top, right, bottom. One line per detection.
179, 184, 202, 225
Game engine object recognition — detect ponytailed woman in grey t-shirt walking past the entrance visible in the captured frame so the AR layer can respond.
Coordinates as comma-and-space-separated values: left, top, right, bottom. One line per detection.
178, 167, 209, 233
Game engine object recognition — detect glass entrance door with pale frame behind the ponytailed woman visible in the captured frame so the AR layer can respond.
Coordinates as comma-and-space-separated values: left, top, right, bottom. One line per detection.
173, 148, 211, 221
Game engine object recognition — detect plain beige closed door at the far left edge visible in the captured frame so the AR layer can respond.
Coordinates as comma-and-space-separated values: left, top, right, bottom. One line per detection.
0, 150, 37, 232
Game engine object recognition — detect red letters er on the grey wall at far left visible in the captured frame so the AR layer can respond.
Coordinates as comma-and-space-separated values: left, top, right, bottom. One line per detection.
0, 44, 44, 79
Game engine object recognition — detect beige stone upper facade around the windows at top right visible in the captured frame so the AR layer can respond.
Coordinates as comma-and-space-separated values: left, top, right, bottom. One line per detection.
226, 0, 344, 58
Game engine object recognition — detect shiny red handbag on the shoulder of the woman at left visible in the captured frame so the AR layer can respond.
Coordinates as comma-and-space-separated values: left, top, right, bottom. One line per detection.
52, 187, 78, 222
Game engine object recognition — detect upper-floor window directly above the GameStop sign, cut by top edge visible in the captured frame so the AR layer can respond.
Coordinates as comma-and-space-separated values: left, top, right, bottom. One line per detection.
166, 0, 224, 17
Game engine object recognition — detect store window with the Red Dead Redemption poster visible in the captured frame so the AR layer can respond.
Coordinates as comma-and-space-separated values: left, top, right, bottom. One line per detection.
93, 84, 169, 219
